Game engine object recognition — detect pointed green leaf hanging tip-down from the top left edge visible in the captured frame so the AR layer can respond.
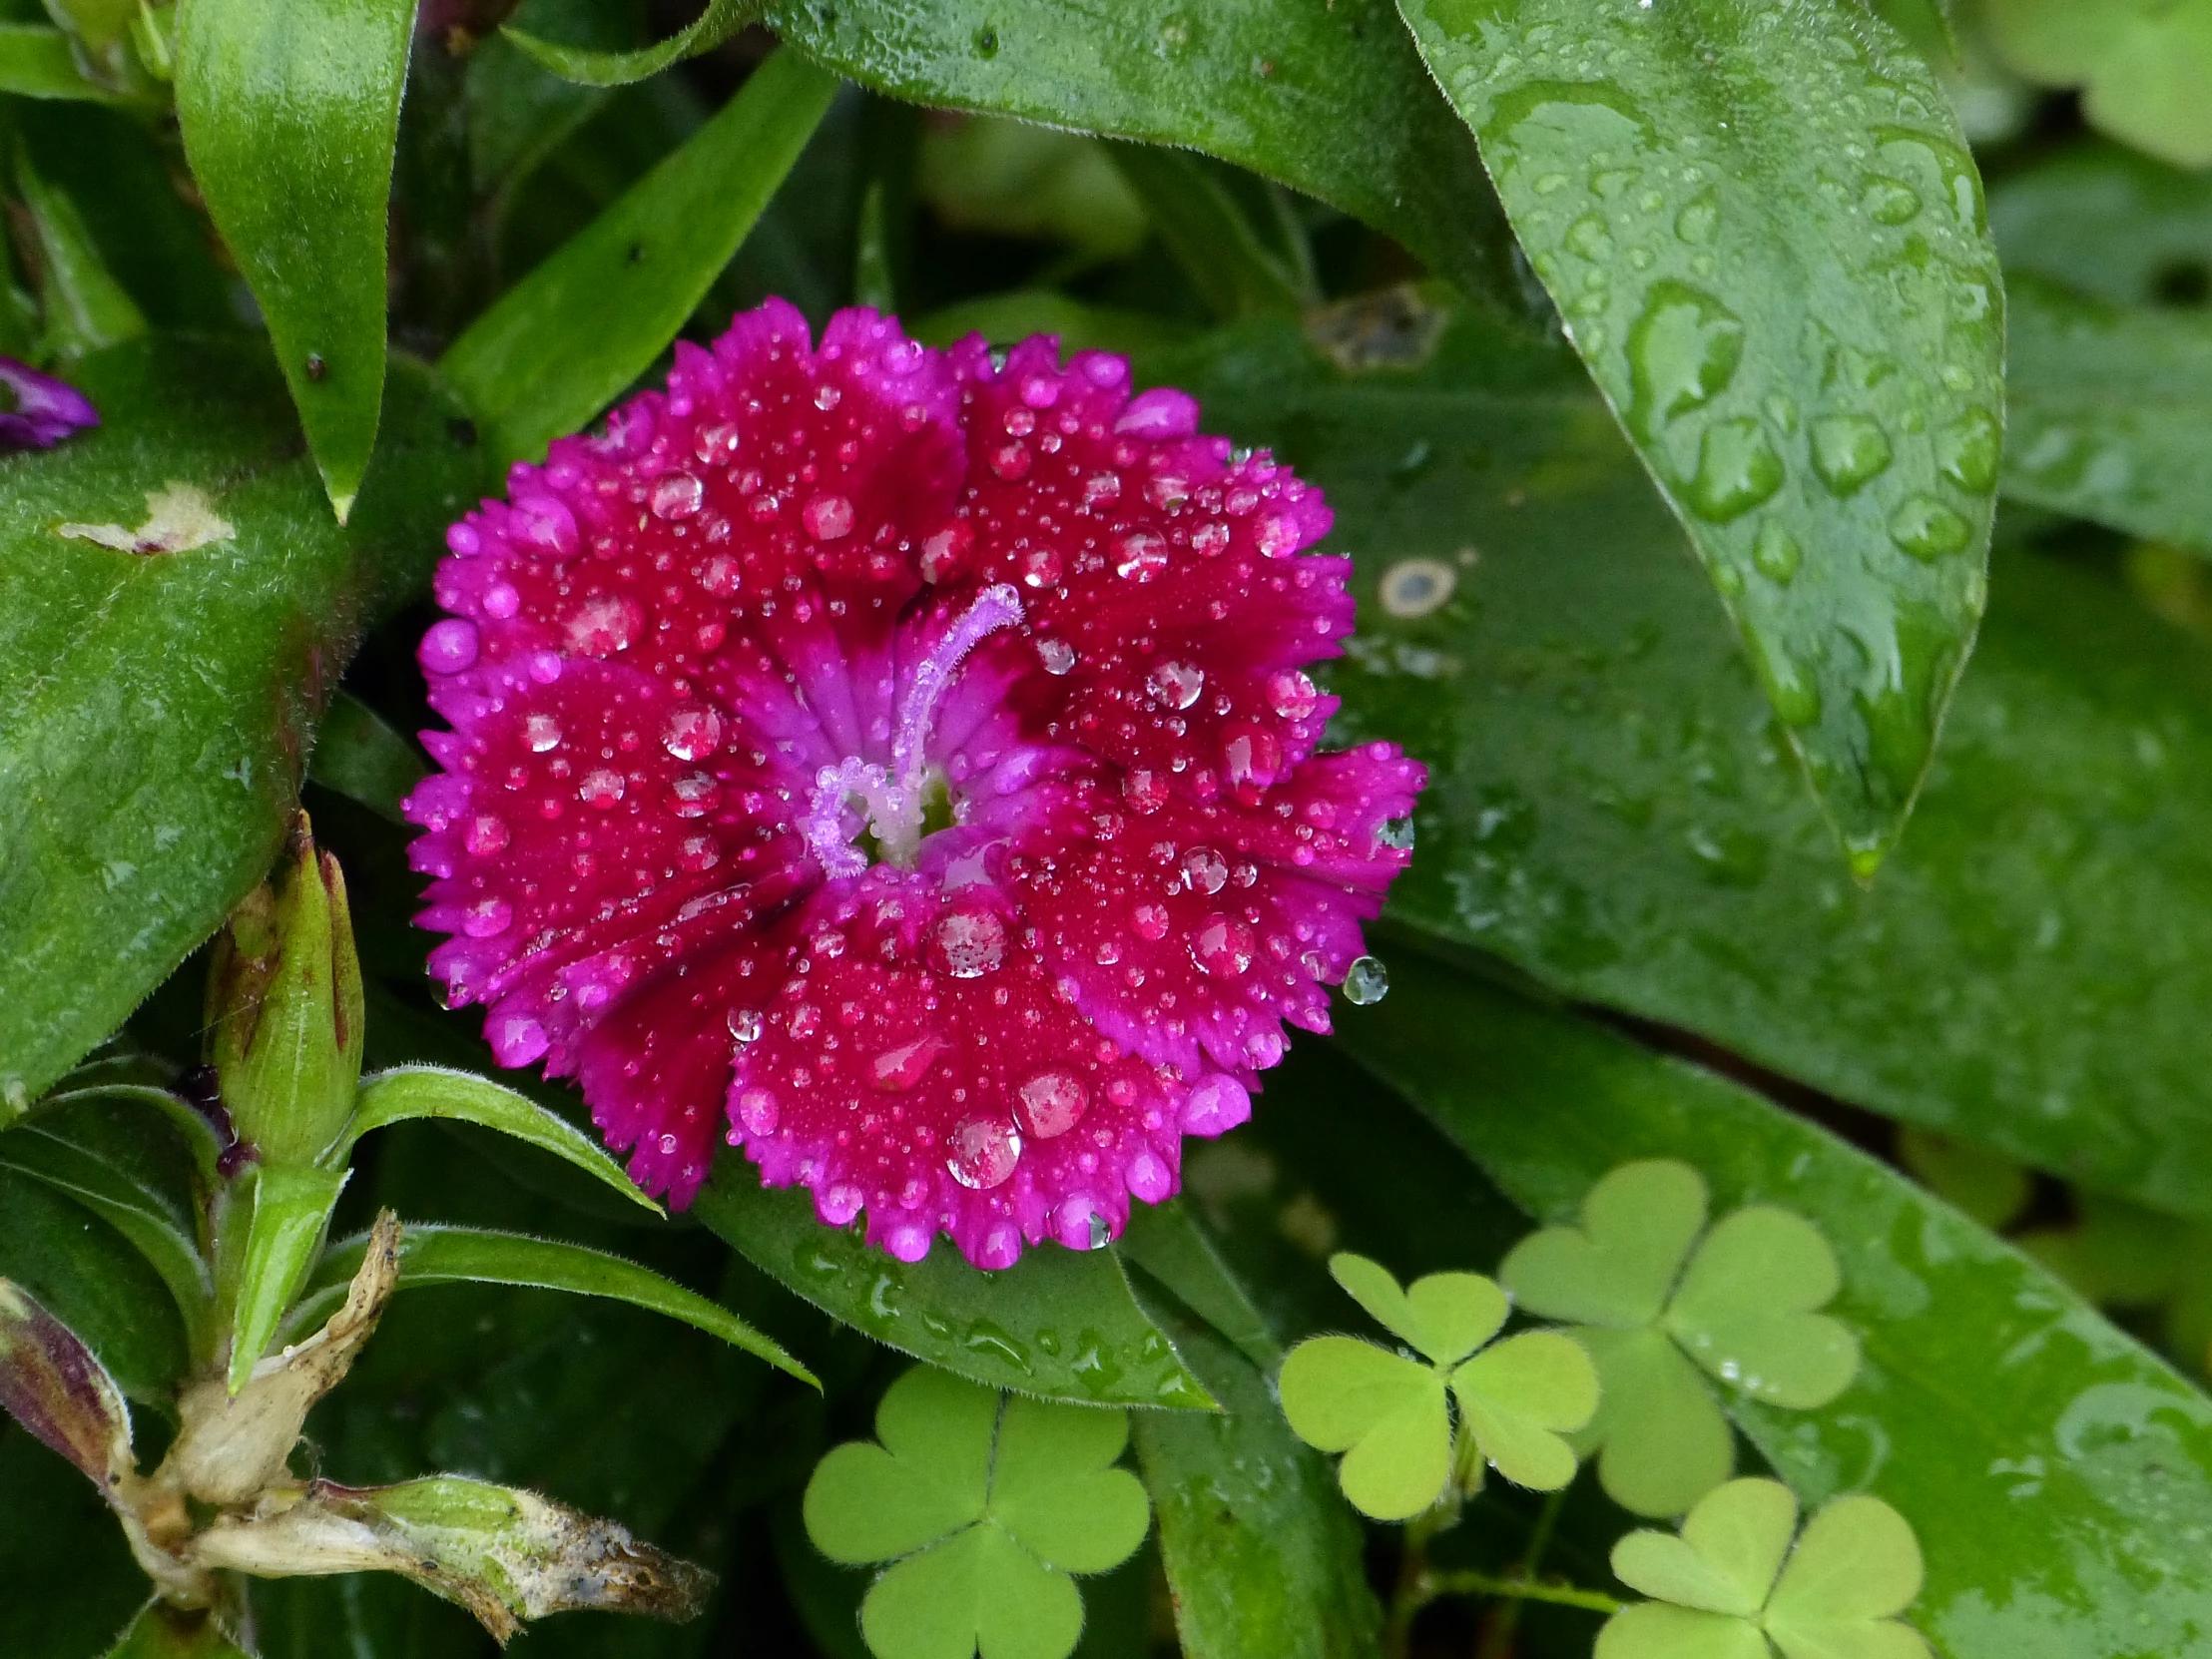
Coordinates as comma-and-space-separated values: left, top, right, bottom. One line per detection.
177, 0, 413, 524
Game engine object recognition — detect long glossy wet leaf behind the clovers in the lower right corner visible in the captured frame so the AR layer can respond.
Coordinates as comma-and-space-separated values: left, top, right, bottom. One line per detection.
1341, 958, 2212, 1659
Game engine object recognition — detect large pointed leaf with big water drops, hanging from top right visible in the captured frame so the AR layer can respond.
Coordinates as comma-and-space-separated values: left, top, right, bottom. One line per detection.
1400, 0, 2004, 876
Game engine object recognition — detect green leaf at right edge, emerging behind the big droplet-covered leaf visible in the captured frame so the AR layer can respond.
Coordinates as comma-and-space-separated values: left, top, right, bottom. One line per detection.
2004, 276, 2212, 553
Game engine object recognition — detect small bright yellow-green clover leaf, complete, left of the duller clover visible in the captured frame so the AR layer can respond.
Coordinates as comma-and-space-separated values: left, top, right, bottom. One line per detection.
1279, 1252, 1597, 1519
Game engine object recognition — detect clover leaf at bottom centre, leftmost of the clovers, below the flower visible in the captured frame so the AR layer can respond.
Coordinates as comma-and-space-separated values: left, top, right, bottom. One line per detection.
806, 1365, 1153, 1659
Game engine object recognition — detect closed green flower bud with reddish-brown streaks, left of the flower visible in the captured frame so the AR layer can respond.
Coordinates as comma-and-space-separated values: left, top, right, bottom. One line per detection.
208, 812, 362, 1164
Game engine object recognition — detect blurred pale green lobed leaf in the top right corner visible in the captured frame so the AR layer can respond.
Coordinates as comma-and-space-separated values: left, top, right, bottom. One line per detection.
1988, 0, 2212, 168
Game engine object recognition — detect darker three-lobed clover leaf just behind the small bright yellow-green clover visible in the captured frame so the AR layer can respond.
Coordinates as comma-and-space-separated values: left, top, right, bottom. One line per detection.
1497, 1159, 1858, 1515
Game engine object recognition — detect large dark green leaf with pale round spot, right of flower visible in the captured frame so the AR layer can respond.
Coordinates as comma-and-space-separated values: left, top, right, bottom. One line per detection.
1144, 294, 2212, 1219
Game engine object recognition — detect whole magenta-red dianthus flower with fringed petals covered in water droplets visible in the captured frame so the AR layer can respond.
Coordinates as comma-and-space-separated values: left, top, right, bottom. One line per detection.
407, 300, 1424, 1268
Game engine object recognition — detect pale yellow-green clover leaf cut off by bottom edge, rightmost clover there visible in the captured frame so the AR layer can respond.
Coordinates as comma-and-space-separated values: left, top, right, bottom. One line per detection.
1597, 1480, 1929, 1659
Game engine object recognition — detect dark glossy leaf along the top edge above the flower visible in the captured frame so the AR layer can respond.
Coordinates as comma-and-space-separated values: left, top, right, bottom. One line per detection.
768, 0, 1493, 287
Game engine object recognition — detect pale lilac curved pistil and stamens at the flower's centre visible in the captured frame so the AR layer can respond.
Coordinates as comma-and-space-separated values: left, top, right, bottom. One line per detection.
801, 582, 1022, 876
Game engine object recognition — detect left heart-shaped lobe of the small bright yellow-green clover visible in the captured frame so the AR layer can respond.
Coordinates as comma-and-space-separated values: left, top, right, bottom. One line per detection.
1277, 1336, 1451, 1519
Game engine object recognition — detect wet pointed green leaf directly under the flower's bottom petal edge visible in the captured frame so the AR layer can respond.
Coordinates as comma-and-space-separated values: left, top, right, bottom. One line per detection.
693, 1157, 1215, 1409
